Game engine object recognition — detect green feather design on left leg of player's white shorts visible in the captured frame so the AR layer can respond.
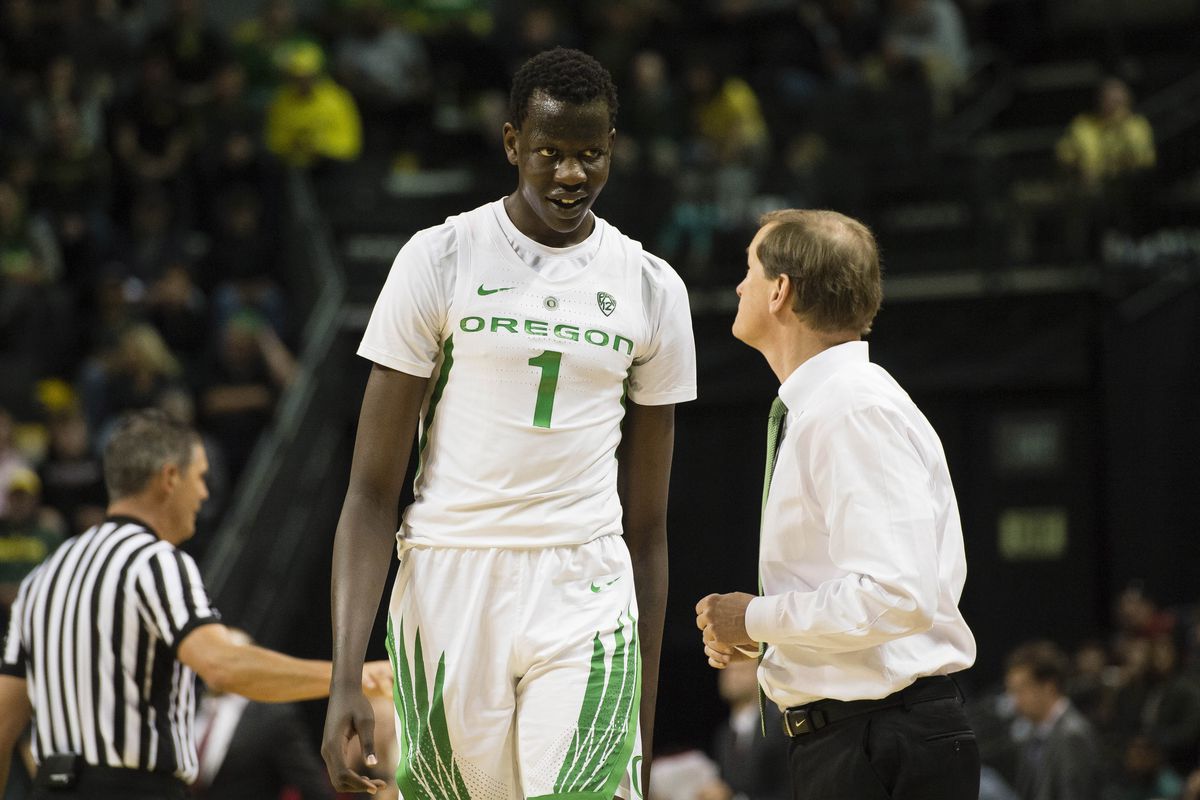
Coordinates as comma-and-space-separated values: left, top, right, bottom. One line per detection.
388, 619, 470, 800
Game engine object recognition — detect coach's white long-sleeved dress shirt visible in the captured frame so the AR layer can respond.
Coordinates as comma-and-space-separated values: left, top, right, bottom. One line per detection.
746, 342, 976, 709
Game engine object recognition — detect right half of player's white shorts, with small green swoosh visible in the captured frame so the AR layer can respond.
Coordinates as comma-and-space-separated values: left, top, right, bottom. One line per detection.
516, 536, 642, 800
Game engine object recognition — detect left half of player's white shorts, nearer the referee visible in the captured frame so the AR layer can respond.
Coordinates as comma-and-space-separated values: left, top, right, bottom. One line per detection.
388, 548, 521, 800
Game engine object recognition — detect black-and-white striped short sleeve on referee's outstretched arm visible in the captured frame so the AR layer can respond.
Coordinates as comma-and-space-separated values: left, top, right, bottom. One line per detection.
134, 547, 221, 652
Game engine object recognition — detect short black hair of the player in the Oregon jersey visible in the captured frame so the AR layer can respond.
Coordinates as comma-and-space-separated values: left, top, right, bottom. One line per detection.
509, 47, 617, 131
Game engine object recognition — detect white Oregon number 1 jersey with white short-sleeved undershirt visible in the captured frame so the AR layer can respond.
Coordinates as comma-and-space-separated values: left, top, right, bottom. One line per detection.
359, 201, 696, 547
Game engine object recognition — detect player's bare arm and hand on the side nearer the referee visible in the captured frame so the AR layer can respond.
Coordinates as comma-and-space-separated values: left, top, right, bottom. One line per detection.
320, 365, 428, 794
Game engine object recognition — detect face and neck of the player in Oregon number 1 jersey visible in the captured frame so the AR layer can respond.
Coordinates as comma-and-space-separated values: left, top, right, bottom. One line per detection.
504, 91, 617, 247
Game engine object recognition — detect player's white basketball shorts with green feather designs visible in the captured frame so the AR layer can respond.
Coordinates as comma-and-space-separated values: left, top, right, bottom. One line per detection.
388, 536, 642, 800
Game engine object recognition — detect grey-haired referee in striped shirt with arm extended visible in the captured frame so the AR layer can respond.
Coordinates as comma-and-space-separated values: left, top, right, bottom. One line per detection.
0, 411, 390, 800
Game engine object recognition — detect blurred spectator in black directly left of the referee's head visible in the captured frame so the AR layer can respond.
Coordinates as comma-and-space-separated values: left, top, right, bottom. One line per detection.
40, 409, 108, 535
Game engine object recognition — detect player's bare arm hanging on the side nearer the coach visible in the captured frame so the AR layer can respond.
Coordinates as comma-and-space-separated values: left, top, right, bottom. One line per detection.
617, 402, 674, 796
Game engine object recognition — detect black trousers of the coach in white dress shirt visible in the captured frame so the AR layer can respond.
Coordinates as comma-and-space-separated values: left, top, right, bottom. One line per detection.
788, 679, 979, 800
